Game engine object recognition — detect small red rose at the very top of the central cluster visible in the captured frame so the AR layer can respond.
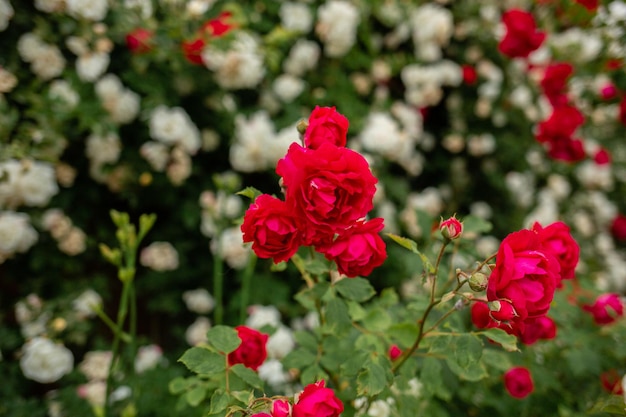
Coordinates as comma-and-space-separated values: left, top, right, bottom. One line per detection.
304, 106, 349, 149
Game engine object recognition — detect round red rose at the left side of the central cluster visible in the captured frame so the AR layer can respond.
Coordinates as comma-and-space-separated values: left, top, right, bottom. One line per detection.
241, 194, 301, 263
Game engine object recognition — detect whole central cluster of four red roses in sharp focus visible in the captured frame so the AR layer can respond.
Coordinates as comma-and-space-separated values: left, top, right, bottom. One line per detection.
241, 107, 387, 277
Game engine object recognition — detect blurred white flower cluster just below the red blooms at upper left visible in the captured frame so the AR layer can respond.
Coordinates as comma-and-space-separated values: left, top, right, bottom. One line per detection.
202, 31, 265, 90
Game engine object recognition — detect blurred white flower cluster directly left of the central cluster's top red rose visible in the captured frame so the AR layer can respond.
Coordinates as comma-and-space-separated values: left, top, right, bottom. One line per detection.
229, 110, 298, 172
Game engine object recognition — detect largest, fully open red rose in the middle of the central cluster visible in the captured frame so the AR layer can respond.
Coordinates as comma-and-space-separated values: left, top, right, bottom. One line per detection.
276, 142, 377, 245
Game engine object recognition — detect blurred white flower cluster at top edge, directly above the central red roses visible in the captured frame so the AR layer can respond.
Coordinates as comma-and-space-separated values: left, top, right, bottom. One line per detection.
315, 0, 361, 58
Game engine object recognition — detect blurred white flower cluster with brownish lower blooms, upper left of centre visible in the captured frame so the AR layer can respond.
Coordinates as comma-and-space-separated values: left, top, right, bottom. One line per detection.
140, 105, 202, 185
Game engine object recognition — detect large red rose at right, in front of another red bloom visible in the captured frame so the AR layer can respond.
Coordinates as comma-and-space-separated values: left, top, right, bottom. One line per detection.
487, 230, 560, 321
